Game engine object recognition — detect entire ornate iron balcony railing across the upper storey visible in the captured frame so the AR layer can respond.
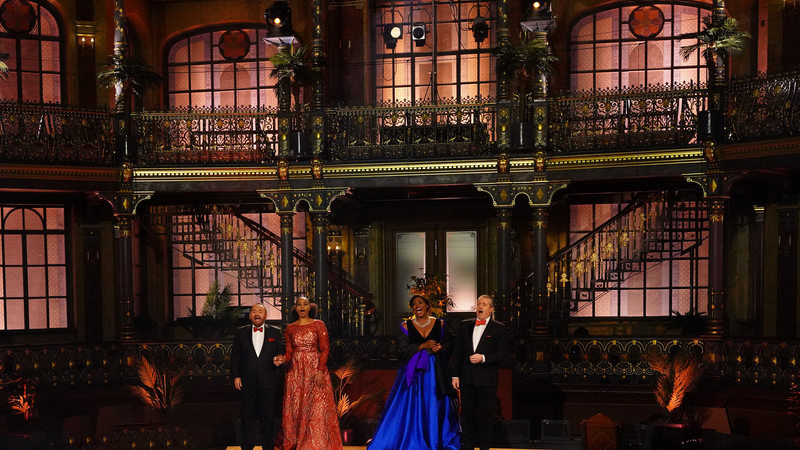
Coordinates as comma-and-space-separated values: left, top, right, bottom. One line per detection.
0, 72, 800, 166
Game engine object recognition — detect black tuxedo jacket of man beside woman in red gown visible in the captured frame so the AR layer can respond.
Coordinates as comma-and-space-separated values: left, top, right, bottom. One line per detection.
231, 324, 283, 389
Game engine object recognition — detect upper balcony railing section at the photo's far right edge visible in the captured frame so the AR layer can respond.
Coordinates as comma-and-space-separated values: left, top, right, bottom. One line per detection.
728, 72, 800, 141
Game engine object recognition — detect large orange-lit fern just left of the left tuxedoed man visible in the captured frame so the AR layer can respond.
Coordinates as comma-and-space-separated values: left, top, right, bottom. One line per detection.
128, 358, 184, 412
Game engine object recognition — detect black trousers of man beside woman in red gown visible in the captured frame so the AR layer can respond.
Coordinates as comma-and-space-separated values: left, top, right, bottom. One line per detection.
242, 387, 275, 450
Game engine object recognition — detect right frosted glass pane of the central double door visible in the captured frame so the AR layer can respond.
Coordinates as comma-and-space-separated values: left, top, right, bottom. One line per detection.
445, 231, 478, 311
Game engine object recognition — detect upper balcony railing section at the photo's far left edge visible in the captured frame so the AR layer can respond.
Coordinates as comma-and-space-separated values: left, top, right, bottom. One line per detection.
0, 101, 114, 165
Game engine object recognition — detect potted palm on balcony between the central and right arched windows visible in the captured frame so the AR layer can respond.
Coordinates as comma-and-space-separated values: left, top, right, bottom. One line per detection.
494, 32, 558, 147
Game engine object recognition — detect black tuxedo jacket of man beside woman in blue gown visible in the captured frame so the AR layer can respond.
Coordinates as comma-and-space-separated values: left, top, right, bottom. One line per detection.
450, 318, 508, 387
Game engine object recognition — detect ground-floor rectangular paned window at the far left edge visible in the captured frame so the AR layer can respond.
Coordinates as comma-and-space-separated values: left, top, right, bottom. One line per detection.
0, 206, 69, 330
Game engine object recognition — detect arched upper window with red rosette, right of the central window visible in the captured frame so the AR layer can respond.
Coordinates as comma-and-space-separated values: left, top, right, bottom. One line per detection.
570, 3, 711, 90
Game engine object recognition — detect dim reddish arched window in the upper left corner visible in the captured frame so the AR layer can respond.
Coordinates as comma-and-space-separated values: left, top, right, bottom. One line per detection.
0, 0, 64, 103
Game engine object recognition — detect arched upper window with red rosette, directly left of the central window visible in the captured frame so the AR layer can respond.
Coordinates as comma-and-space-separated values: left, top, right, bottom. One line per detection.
166, 25, 278, 108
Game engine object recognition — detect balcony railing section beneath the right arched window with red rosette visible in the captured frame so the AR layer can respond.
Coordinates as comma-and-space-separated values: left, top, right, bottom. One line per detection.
548, 83, 707, 153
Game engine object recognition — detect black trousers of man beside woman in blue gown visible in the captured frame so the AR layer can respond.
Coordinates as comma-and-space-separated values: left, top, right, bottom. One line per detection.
460, 384, 497, 450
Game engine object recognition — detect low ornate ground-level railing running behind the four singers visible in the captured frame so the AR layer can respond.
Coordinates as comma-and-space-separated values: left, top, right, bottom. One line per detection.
0, 336, 800, 388
